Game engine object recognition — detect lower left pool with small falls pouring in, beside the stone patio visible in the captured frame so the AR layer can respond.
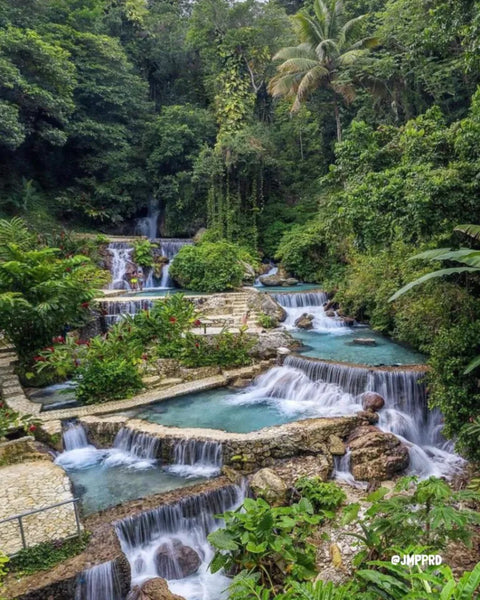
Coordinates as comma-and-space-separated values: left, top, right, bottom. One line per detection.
55, 423, 212, 514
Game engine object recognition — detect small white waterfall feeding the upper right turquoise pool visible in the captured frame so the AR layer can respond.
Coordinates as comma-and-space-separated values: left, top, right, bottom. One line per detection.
272, 291, 349, 333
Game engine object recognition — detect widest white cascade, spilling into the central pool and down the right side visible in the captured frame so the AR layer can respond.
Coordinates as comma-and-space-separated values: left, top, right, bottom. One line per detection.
229, 356, 462, 477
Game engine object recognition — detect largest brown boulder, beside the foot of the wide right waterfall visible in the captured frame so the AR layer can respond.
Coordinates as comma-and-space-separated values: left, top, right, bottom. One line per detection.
347, 425, 410, 481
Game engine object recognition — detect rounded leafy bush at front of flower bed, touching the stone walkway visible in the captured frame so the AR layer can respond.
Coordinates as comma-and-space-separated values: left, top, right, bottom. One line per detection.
74, 358, 143, 404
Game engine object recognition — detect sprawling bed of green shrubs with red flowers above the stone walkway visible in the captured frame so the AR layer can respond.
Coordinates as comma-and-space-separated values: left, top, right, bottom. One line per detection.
35, 294, 254, 404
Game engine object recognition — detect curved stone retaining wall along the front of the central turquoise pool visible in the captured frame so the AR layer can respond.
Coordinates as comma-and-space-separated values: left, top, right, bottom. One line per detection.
80, 416, 359, 473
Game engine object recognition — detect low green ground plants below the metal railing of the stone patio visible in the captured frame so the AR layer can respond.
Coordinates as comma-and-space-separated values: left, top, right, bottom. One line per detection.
10, 532, 90, 575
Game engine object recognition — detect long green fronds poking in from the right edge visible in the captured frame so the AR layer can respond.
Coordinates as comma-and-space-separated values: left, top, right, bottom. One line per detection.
389, 225, 480, 375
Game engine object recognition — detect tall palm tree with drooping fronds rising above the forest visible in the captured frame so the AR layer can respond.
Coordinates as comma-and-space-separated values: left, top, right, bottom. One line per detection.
269, 0, 378, 142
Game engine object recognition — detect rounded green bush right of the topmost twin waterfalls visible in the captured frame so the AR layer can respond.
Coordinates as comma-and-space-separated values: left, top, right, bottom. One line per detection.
169, 242, 249, 292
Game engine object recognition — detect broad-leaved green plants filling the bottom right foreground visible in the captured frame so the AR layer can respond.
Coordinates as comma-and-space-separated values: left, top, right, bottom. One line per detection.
216, 477, 480, 600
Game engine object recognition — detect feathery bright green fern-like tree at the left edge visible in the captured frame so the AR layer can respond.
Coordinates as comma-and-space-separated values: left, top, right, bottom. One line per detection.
0, 219, 104, 366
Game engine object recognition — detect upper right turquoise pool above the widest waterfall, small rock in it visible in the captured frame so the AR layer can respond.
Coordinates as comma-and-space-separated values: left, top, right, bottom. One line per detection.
291, 327, 425, 366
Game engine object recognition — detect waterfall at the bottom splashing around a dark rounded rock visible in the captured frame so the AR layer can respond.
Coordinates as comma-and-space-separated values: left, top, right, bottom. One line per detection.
115, 485, 245, 600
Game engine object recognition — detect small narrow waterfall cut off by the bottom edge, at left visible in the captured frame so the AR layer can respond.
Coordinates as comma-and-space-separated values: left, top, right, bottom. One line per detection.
75, 560, 123, 600
